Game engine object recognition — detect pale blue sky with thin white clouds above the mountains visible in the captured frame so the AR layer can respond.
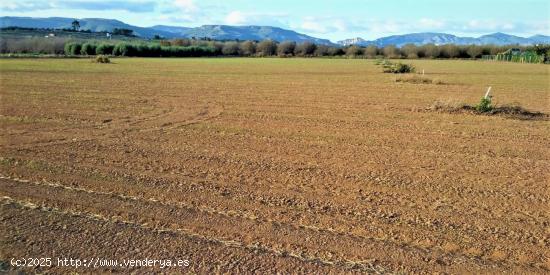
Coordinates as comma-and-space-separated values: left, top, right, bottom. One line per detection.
0, 0, 550, 41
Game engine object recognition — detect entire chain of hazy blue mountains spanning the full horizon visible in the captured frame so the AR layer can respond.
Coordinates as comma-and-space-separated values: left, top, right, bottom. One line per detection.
0, 16, 550, 47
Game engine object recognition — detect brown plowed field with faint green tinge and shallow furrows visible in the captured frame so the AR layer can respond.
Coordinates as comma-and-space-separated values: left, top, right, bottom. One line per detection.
0, 58, 550, 274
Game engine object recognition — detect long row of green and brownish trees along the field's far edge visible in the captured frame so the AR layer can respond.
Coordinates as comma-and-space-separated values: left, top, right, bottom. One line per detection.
0, 38, 550, 59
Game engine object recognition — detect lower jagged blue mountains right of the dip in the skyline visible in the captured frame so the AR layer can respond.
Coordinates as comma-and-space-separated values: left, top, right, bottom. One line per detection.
337, 32, 550, 47
